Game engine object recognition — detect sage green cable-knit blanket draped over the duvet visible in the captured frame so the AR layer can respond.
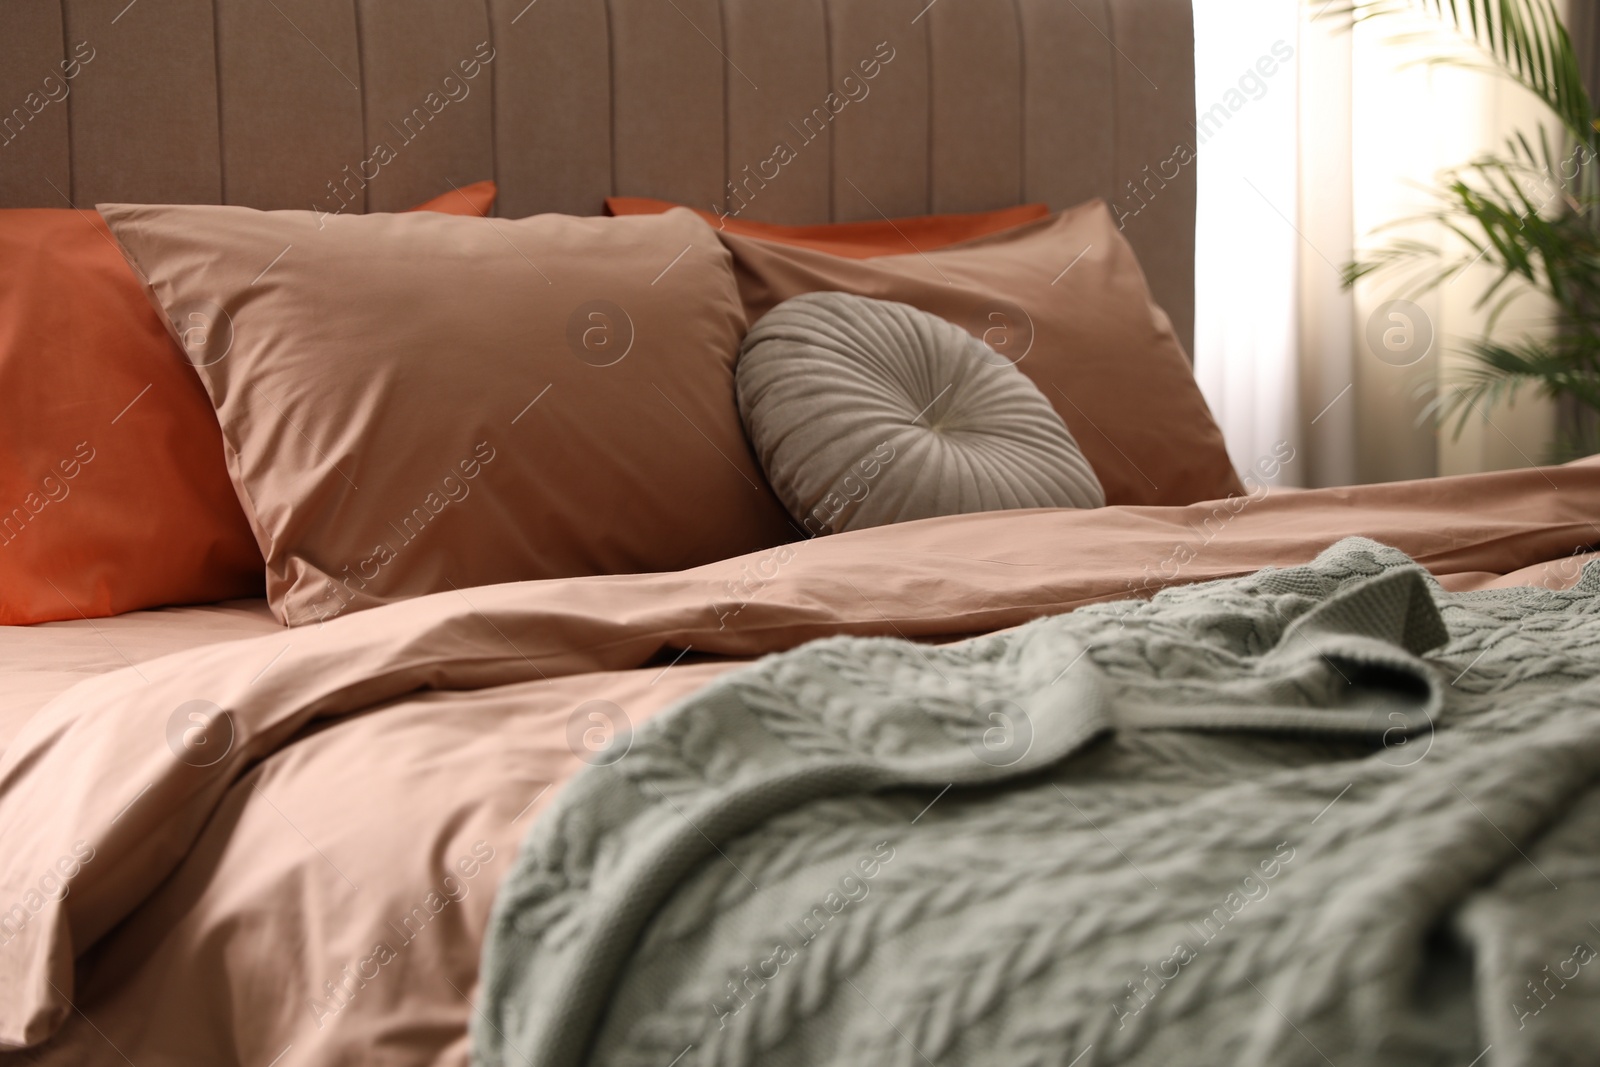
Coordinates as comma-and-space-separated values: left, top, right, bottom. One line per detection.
474, 539, 1600, 1067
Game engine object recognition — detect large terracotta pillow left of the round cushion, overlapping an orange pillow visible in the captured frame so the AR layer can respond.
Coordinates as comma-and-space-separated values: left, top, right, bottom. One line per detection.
101, 205, 797, 624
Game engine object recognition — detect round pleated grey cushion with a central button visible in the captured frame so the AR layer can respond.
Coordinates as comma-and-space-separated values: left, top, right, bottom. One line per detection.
736, 293, 1106, 536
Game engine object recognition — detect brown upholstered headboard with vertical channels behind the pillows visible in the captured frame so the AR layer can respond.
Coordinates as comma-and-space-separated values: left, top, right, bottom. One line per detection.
0, 0, 1195, 344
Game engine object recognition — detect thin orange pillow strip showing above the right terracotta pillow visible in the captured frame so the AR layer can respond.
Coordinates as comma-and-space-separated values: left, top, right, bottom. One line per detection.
605, 197, 1050, 259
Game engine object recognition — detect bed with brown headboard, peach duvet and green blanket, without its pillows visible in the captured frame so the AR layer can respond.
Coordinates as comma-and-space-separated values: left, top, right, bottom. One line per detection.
0, 0, 1600, 1067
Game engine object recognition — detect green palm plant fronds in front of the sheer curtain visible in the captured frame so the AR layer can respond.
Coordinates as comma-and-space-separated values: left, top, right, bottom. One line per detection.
1344, 0, 1600, 453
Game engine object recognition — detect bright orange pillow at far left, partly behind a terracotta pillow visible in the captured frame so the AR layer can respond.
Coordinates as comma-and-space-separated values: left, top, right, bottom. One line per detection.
0, 181, 494, 625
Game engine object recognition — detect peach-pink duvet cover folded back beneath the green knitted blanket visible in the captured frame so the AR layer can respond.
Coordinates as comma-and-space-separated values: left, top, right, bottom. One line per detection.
0, 462, 1600, 1067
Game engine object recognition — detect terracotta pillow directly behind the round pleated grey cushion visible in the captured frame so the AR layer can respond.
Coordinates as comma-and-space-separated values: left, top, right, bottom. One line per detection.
718, 200, 1243, 504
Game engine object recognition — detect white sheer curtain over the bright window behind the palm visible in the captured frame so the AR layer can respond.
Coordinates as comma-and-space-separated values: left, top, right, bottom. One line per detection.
1195, 0, 1554, 485
